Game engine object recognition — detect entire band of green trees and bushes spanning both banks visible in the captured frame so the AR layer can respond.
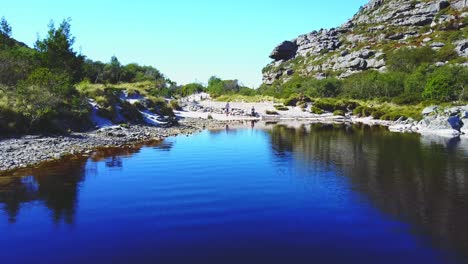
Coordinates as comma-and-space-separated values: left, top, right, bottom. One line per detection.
0, 14, 468, 134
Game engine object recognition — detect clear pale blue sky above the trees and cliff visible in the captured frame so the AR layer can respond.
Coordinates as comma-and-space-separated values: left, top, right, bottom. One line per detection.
0, 0, 368, 87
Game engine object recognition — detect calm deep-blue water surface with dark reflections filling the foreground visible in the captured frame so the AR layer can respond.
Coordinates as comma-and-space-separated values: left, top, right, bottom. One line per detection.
0, 125, 468, 263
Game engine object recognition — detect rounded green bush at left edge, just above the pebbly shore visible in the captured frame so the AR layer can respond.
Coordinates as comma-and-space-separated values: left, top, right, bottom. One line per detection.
0, 68, 90, 133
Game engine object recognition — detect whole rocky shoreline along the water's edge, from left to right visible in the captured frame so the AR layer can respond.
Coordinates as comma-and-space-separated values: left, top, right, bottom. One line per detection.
0, 106, 468, 175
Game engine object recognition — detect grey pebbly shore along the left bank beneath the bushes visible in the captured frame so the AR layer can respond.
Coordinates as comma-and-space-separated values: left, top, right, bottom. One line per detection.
0, 119, 234, 175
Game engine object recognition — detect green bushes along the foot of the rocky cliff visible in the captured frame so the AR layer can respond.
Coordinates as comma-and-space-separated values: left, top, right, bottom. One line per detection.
258, 47, 468, 104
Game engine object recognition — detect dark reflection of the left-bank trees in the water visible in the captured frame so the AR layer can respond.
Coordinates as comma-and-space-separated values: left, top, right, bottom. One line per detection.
0, 142, 166, 224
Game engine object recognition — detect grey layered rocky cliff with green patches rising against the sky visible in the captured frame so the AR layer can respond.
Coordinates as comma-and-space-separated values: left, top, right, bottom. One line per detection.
263, 0, 468, 84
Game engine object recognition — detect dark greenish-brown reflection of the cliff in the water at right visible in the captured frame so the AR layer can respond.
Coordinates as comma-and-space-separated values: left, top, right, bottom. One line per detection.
270, 125, 468, 255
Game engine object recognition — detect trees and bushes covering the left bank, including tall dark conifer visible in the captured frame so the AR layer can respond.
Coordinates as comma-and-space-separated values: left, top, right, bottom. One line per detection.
0, 18, 181, 134
